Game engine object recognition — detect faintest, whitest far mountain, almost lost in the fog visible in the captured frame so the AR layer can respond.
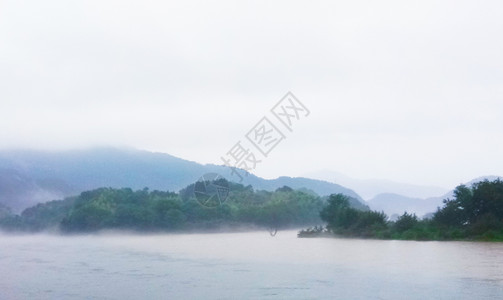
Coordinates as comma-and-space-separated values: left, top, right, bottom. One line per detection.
305, 170, 448, 200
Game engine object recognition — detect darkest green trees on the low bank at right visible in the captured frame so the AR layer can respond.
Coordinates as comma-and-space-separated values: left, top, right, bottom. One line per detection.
299, 179, 503, 241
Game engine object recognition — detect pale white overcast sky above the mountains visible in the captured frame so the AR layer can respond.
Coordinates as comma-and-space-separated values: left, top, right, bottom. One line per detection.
0, 0, 503, 188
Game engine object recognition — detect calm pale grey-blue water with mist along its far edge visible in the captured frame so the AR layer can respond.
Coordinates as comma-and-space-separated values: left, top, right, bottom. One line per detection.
0, 231, 503, 300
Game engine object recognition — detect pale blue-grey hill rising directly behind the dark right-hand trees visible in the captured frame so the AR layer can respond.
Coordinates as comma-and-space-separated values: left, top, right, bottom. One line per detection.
367, 176, 502, 217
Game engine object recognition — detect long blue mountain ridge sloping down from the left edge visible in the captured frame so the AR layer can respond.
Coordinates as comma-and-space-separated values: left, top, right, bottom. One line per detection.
0, 148, 363, 213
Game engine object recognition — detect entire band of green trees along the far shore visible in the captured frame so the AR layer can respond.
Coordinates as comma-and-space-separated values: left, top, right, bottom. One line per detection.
4, 180, 503, 240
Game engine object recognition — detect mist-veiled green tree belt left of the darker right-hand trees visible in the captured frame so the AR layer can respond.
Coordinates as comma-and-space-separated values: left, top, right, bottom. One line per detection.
0, 183, 323, 232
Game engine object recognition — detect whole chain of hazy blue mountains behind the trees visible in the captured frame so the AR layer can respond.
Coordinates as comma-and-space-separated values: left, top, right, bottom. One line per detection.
0, 147, 499, 216
